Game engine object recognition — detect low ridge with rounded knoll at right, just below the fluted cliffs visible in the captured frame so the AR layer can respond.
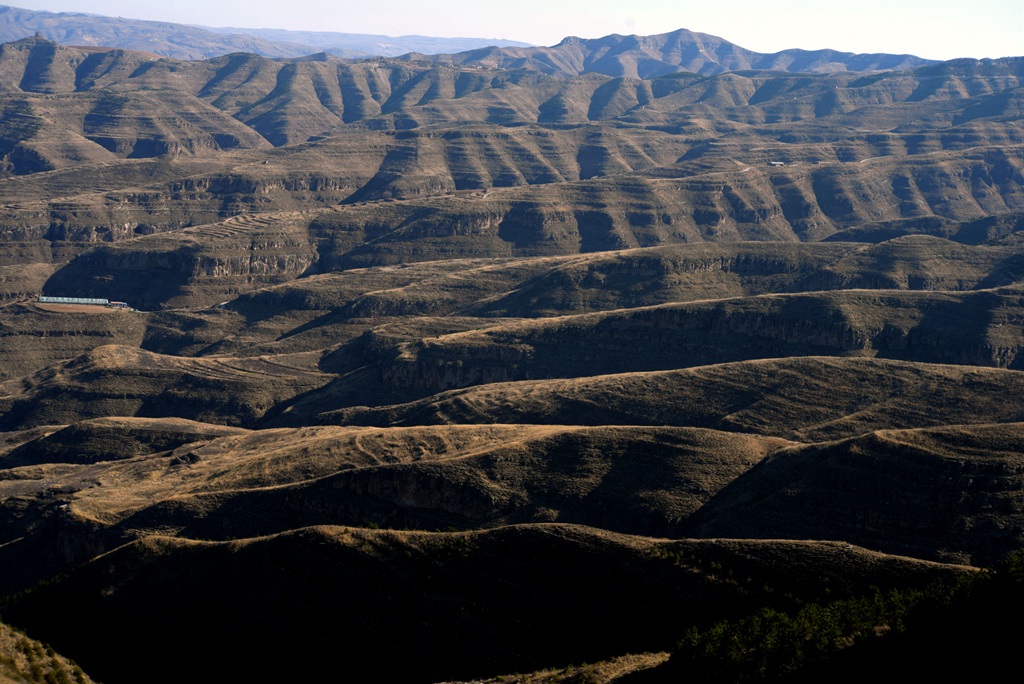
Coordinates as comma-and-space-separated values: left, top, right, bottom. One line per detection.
190, 237, 1024, 335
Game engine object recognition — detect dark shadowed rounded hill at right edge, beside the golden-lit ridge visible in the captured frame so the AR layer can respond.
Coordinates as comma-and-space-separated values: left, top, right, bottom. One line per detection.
687, 423, 1024, 564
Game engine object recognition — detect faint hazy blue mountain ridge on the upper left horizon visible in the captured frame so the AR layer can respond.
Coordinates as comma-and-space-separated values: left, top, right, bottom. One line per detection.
0, 5, 528, 59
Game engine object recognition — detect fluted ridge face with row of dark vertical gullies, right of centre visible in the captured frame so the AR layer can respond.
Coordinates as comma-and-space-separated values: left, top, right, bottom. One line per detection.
309, 148, 1024, 267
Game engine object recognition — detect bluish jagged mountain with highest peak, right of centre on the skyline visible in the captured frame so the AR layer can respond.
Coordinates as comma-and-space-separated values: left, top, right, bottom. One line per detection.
410, 29, 937, 78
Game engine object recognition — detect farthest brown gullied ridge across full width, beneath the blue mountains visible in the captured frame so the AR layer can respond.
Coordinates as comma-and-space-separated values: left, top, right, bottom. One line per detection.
0, 38, 1020, 160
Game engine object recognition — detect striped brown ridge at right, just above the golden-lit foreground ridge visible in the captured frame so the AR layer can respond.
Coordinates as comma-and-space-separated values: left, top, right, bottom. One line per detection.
327, 357, 1024, 441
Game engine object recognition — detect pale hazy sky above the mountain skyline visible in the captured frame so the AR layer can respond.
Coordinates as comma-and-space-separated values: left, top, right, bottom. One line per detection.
10, 0, 1024, 59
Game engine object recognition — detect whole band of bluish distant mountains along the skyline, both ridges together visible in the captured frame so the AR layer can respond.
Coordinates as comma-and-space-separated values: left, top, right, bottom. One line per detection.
0, 5, 938, 79
